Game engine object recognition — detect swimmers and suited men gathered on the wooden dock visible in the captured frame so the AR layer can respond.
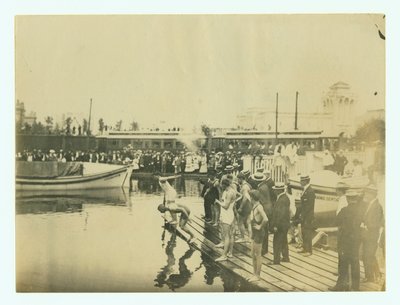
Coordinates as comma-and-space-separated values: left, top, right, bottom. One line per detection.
159, 165, 384, 291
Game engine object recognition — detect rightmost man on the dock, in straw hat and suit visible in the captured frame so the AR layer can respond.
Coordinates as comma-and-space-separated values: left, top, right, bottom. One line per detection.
361, 185, 385, 282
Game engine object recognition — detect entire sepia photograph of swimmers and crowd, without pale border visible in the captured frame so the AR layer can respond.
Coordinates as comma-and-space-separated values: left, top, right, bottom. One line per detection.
11, 12, 389, 293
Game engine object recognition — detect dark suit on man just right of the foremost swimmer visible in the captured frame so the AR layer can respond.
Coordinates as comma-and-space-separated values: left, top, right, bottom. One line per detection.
271, 194, 290, 264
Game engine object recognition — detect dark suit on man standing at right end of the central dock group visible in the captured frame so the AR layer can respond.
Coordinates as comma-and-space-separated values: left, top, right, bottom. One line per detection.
300, 186, 315, 253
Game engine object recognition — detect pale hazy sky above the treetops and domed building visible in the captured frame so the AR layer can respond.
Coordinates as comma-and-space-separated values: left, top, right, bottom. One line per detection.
15, 14, 385, 128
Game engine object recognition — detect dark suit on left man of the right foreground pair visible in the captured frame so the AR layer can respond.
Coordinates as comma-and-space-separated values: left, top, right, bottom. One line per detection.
336, 203, 362, 290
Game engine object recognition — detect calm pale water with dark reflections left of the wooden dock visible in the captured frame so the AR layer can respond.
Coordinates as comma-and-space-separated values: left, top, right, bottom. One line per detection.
16, 179, 255, 292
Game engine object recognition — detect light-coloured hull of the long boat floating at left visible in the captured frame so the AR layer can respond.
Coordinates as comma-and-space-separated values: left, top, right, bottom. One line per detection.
15, 166, 132, 191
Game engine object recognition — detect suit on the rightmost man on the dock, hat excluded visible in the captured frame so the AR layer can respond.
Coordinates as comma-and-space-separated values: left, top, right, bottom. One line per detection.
362, 199, 384, 281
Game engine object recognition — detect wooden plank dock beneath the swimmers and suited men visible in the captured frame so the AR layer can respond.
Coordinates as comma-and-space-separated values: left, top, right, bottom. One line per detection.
169, 215, 381, 292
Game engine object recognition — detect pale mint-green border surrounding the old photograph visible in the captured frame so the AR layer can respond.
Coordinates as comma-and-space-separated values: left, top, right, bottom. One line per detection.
0, 0, 400, 305
